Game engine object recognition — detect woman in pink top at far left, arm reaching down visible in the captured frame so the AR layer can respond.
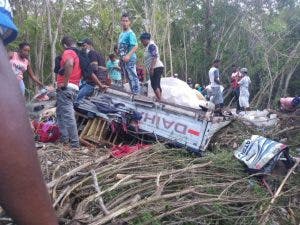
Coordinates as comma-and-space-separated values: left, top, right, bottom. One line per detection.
8, 42, 44, 95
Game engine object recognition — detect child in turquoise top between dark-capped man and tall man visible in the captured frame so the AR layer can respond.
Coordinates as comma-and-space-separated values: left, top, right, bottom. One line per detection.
106, 54, 122, 87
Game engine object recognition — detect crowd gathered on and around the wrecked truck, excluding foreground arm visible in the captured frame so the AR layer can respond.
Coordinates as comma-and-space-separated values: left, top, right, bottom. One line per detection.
8, 13, 251, 148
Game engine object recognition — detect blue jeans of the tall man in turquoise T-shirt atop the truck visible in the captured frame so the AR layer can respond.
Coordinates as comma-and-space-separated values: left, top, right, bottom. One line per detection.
124, 59, 140, 94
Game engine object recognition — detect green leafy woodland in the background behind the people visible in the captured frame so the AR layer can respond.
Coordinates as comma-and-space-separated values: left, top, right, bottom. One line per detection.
10, 0, 300, 101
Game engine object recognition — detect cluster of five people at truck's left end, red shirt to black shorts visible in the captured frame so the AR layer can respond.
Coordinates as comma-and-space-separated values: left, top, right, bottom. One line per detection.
50, 14, 164, 149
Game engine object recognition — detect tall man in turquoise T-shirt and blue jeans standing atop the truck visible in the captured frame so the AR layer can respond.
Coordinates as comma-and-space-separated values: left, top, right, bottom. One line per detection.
118, 13, 140, 94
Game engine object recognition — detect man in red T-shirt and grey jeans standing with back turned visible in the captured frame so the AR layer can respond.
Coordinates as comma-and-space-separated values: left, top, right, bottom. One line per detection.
56, 36, 82, 149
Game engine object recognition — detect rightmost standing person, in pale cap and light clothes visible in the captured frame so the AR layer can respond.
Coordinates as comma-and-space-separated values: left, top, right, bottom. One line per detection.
238, 68, 251, 111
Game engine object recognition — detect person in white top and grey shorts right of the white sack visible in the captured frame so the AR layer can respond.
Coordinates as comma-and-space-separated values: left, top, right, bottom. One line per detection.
208, 59, 223, 111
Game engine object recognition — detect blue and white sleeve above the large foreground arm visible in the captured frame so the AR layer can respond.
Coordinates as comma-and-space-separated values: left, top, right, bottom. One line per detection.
0, 0, 18, 45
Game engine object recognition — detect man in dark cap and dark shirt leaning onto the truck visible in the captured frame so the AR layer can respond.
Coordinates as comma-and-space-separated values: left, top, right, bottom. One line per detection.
76, 39, 108, 102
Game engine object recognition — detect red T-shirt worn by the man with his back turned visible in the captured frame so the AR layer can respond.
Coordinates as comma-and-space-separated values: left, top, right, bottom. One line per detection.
57, 49, 81, 86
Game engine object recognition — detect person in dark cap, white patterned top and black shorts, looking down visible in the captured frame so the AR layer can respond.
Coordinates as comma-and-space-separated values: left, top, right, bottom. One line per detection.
140, 33, 164, 101
